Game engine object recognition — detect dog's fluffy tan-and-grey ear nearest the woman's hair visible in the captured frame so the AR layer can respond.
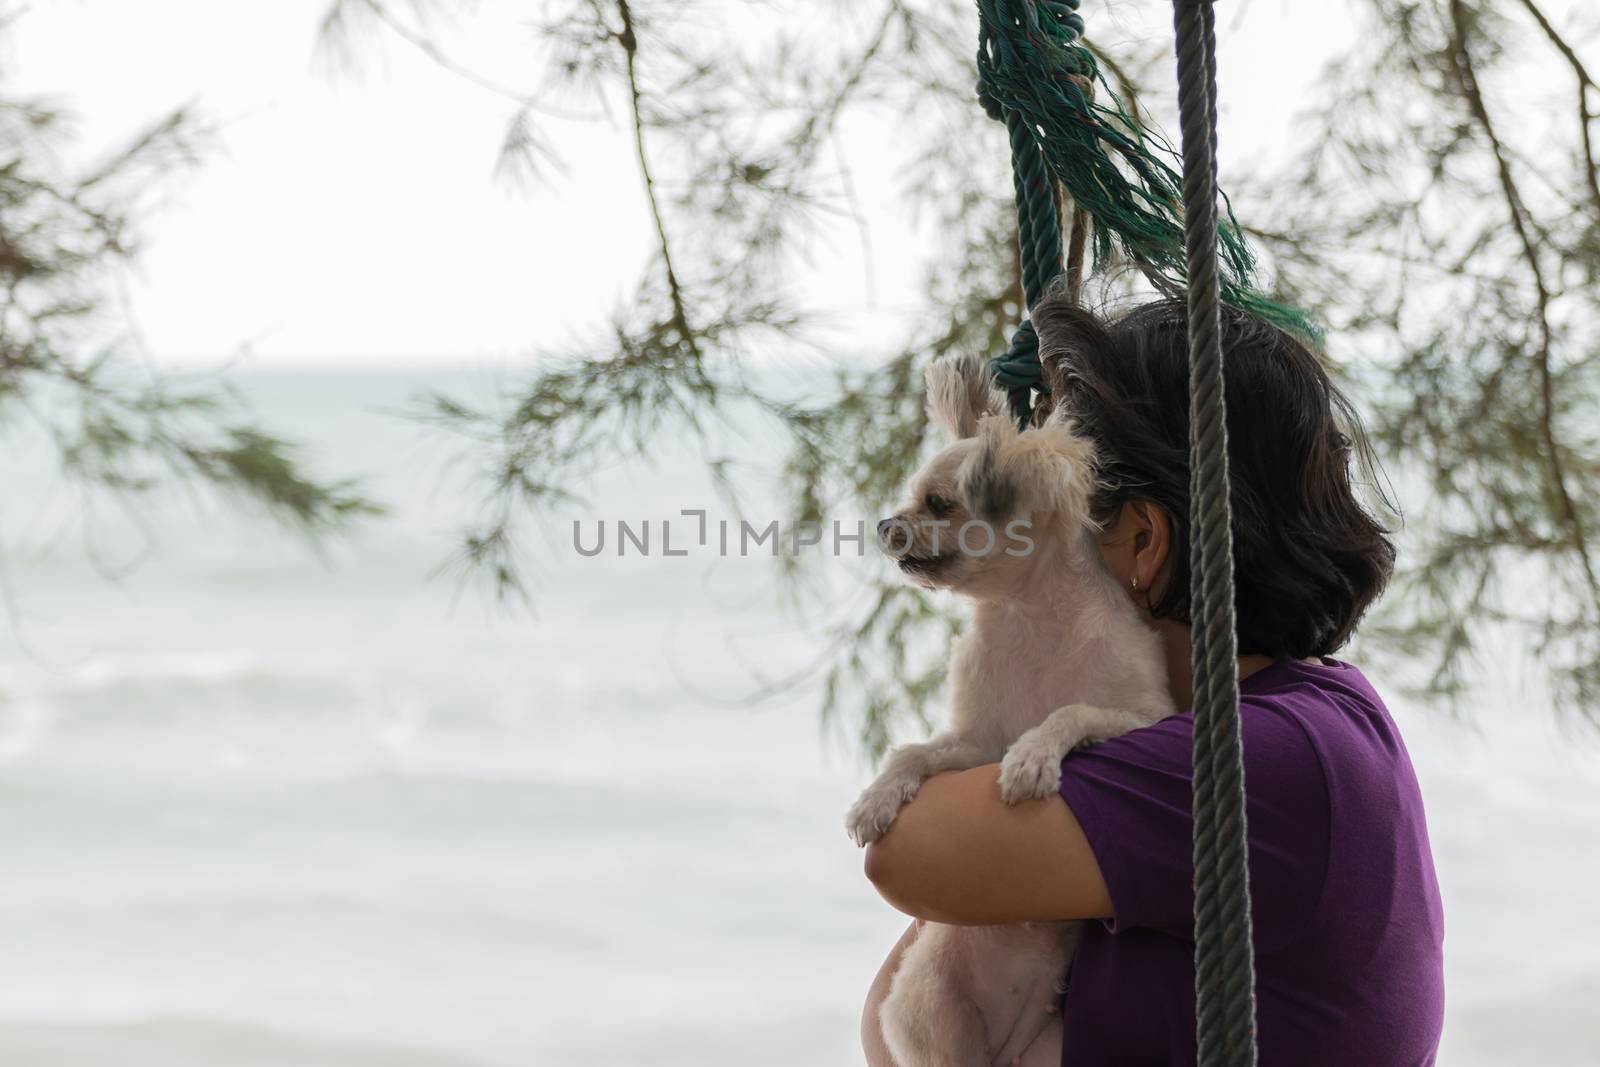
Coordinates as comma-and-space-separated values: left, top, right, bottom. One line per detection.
958, 414, 1096, 522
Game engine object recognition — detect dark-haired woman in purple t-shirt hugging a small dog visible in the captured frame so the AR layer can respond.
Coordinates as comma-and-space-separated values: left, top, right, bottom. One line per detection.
862, 298, 1443, 1067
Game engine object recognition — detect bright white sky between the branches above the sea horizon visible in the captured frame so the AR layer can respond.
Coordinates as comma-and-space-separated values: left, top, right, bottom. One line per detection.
6, 0, 1352, 366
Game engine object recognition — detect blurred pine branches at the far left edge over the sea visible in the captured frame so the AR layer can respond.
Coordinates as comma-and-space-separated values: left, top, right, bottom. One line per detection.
0, 18, 376, 575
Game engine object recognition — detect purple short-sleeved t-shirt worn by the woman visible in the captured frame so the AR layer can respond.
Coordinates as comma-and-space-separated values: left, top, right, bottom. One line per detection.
1061, 661, 1445, 1067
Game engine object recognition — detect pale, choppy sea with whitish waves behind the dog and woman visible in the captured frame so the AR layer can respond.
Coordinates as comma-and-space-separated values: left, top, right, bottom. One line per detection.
0, 370, 1600, 1067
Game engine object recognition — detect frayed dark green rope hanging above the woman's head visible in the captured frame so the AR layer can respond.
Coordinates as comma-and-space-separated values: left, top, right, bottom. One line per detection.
978, 0, 1317, 426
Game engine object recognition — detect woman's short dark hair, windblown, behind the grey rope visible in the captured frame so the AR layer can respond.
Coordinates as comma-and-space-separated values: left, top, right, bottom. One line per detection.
1032, 296, 1395, 659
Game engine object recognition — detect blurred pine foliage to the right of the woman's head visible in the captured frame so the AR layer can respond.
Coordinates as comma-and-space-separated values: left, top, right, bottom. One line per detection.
1251, 0, 1600, 718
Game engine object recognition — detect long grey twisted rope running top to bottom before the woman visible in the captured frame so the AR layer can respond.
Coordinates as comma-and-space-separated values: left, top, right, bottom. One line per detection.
1173, 0, 1256, 1067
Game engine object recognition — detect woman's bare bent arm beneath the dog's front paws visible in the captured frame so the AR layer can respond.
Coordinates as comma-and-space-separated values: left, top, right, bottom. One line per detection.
867, 763, 1112, 927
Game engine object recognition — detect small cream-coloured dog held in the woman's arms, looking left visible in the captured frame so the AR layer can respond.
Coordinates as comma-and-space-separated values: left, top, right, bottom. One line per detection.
846, 357, 1174, 1067
